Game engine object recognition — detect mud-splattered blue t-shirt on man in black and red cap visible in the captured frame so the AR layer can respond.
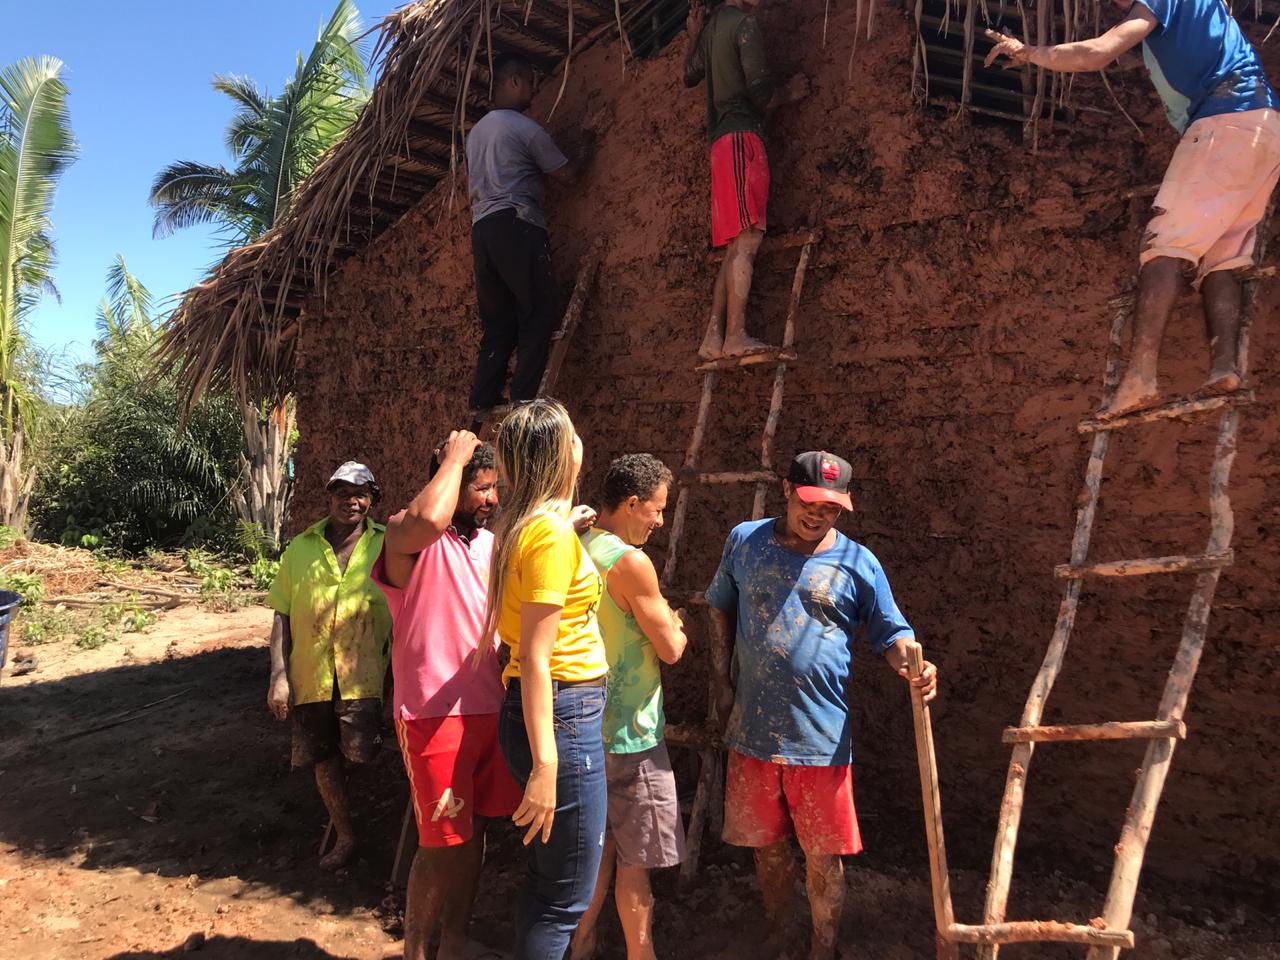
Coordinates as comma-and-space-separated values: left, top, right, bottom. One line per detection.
707, 520, 911, 767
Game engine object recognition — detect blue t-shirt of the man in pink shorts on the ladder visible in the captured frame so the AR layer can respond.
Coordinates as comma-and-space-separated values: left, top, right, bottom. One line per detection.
1137, 0, 1280, 133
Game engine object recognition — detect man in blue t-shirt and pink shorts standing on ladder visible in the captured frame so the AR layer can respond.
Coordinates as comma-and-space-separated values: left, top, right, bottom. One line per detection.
987, 0, 1280, 420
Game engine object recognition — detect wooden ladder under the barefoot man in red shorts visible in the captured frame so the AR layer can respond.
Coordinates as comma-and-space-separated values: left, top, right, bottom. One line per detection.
662, 229, 819, 886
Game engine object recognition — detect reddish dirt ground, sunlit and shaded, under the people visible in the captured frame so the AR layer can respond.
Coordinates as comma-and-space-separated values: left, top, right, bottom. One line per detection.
0, 605, 1280, 960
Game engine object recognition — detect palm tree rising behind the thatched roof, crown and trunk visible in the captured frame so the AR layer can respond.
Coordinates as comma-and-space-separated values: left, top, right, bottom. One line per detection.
151, 0, 369, 552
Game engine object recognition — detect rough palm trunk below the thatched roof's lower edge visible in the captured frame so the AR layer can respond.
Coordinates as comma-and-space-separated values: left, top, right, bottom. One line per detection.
236, 397, 294, 549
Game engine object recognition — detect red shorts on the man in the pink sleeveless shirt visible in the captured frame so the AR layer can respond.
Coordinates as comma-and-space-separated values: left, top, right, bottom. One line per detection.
396, 713, 525, 846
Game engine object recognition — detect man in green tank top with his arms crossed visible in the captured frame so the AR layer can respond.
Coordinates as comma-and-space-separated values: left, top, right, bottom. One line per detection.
570, 453, 685, 960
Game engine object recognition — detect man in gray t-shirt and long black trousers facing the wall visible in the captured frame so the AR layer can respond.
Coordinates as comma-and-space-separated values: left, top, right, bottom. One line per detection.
467, 54, 577, 421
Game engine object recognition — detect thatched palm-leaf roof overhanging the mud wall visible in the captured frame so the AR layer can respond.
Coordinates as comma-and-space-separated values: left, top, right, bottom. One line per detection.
161, 0, 653, 399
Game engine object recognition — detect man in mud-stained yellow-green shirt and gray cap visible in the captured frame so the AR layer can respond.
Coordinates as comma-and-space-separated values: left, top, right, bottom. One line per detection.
266, 461, 392, 870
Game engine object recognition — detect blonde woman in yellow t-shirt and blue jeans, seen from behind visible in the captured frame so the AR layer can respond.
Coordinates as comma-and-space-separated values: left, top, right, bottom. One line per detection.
485, 399, 608, 960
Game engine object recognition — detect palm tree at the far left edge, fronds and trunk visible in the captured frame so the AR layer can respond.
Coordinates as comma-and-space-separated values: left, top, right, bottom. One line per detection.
0, 56, 76, 529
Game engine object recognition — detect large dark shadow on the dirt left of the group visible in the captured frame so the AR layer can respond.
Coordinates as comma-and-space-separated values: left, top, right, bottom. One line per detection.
0, 646, 407, 916
